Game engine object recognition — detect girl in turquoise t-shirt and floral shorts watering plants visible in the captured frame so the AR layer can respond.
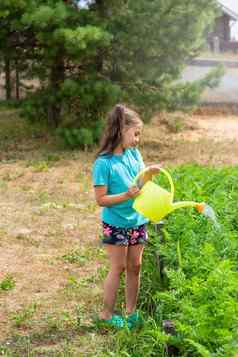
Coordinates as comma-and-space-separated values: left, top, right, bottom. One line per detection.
93, 104, 159, 328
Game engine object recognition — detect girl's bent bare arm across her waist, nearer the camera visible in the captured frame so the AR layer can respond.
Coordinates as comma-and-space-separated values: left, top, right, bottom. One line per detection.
94, 186, 140, 207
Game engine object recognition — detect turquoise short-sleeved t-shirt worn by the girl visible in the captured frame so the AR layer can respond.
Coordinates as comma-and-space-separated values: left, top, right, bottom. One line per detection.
93, 148, 148, 228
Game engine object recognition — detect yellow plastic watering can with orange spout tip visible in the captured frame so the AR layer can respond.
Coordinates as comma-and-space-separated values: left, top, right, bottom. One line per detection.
133, 168, 205, 223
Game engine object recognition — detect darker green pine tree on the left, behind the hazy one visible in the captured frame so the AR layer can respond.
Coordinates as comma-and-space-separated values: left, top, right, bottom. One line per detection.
19, 0, 115, 126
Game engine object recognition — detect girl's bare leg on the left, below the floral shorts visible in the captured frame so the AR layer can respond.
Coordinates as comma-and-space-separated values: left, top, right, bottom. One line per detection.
100, 244, 127, 320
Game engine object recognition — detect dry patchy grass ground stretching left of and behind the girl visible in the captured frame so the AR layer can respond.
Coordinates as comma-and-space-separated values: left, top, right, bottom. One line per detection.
0, 110, 237, 357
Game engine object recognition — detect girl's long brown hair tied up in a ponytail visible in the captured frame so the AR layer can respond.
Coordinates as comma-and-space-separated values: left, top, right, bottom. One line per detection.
97, 104, 142, 156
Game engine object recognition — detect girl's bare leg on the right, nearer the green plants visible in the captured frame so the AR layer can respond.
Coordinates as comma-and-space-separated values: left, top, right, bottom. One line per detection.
126, 244, 144, 315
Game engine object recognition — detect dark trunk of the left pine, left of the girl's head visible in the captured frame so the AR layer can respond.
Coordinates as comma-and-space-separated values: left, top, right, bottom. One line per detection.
48, 55, 65, 128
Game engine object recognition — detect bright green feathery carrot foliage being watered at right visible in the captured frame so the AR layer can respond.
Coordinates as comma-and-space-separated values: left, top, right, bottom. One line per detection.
112, 165, 238, 357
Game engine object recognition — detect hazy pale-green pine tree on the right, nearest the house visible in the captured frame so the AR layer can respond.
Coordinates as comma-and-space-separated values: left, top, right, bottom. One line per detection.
95, 0, 219, 115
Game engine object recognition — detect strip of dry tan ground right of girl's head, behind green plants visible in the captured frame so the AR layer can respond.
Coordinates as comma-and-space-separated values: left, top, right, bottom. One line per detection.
143, 112, 238, 165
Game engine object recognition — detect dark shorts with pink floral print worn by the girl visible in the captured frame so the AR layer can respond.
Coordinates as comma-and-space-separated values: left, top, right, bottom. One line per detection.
102, 222, 148, 246
